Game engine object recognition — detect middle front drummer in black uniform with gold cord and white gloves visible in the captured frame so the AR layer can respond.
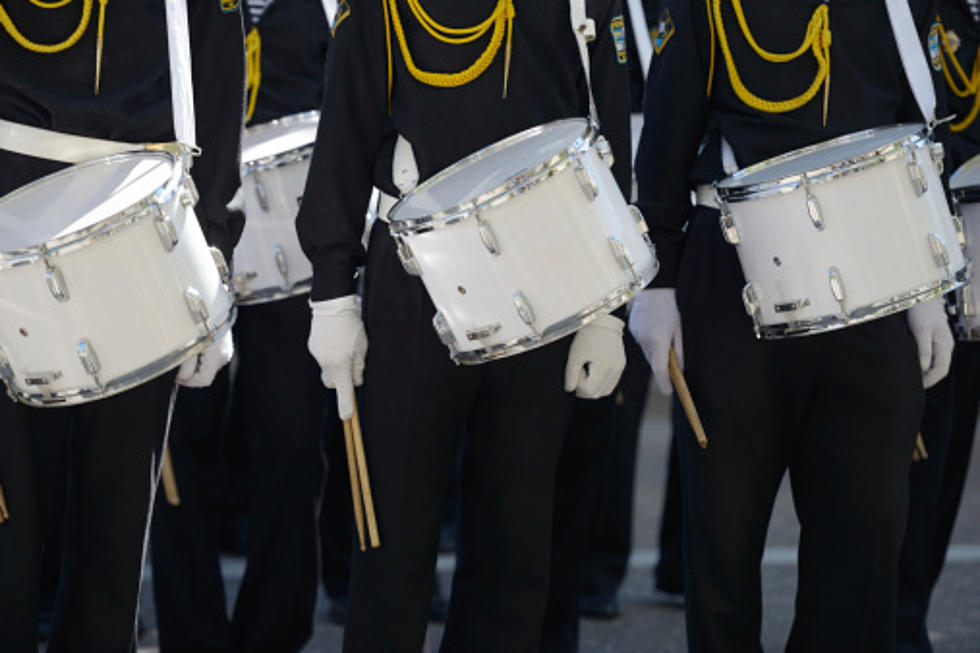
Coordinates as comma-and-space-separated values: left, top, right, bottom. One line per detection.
297, 0, 629, 653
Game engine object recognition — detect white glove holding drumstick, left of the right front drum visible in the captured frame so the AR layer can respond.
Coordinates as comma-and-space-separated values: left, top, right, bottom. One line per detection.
630, 288, 684, 397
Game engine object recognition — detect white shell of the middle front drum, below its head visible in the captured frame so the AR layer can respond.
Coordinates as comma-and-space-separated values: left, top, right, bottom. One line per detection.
392, 121, 657, 364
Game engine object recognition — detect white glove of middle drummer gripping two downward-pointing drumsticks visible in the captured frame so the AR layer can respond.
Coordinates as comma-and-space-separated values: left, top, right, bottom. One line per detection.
306, 295, 367, 420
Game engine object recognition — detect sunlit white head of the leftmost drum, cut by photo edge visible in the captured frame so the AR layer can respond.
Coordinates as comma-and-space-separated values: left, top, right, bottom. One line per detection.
0, 152, 176, 252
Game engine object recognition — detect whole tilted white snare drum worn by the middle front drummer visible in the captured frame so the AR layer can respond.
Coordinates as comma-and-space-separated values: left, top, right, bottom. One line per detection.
388, 119, 657, 364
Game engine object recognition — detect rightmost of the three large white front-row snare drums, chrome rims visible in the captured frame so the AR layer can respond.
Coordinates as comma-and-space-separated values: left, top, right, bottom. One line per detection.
715, 125, 966, 338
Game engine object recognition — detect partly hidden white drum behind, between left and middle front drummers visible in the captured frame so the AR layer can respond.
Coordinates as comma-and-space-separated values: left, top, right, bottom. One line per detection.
232, 111, 320, 304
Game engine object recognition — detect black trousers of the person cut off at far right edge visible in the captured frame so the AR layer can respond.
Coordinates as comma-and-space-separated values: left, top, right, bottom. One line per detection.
896, 342, 980, 653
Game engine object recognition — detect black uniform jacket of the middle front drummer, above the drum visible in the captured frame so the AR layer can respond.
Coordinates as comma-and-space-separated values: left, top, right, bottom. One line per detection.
297, 0, 630, 300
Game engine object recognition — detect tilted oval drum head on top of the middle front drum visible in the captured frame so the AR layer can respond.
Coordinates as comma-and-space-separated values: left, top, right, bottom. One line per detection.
388, 118, 588, 221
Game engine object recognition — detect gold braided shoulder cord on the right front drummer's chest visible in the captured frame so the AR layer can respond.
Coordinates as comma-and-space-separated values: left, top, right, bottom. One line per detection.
706, 0, 831, 125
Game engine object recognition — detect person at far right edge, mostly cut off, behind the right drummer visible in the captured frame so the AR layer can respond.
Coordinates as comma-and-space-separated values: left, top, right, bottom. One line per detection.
896, 0, 980, 653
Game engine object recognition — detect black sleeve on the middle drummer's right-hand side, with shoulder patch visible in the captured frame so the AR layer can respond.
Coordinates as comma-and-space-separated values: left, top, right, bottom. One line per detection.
590, 0, 632, 200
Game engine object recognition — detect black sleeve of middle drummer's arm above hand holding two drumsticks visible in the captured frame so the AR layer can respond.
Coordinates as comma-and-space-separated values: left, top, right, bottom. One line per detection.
296, 2, 391, 301
